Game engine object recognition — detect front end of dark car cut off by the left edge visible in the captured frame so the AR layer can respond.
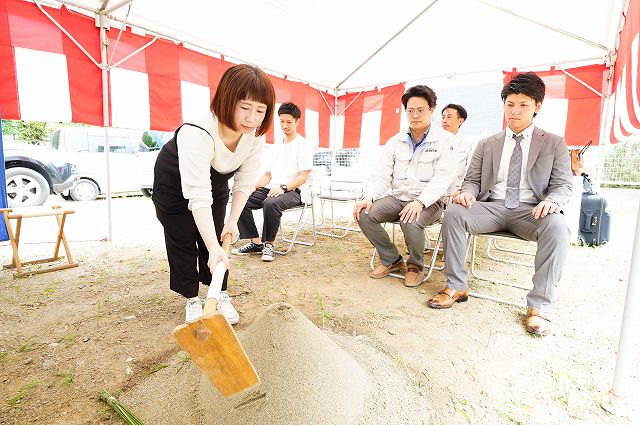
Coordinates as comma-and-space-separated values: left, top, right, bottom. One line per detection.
3, 141, 80, 208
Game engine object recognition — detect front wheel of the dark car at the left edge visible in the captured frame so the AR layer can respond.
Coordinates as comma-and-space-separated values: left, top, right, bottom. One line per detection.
5, 167, 50, 208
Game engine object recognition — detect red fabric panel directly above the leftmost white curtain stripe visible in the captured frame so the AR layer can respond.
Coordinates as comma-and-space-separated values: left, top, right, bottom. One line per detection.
7, 0, 63, 53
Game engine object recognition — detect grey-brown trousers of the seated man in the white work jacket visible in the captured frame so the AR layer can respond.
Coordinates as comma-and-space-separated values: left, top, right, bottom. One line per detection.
359, 195, 444, 270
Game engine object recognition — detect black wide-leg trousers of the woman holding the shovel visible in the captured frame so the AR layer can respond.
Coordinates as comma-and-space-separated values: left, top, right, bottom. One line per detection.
156, 199, 229, 298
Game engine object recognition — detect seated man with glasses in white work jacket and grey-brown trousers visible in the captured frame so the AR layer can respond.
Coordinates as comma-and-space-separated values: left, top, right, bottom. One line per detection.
353, 85, 457, 287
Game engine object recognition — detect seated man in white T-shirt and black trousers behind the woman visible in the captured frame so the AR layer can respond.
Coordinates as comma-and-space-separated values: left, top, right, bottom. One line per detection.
231, 102, 313, 261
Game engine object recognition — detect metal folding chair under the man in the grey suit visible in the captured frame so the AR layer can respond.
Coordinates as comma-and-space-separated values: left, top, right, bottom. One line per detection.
467, 231, 537, 308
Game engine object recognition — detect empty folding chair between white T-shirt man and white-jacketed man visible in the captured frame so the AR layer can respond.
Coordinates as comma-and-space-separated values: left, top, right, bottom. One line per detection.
316, 167, 365, 238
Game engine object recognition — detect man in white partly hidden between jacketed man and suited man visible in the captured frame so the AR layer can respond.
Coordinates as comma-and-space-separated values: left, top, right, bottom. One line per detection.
442, 103, 477, 198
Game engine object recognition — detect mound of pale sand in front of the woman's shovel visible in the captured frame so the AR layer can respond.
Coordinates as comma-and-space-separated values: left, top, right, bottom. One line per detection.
123, 303, 429, 425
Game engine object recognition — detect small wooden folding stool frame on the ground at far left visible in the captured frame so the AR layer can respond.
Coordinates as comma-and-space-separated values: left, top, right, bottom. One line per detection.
0, 205, 78, 277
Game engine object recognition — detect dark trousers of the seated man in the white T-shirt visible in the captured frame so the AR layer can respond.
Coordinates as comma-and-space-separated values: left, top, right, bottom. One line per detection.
238, 187, 301, 242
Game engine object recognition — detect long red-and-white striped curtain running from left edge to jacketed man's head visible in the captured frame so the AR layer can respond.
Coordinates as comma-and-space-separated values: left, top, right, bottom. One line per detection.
0, 0, 402, 147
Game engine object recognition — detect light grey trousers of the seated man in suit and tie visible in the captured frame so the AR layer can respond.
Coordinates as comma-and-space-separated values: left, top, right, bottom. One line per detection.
442, 200, 570, 313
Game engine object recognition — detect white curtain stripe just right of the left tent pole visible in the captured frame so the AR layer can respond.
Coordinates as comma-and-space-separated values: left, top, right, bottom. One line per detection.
110, 68, 151, 128
